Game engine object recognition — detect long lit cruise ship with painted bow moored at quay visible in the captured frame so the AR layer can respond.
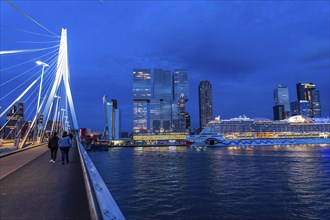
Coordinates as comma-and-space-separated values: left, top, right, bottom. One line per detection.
186, 115, 330, 147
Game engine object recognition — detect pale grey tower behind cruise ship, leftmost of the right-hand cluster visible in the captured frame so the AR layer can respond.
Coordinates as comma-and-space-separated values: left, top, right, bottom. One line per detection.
273, 84, 290, 120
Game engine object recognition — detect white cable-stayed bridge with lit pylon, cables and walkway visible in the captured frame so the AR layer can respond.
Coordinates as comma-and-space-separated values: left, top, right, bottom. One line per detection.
0, 0, 124, 219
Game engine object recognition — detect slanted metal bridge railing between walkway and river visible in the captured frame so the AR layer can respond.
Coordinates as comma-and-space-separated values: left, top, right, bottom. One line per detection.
76, 137, 125, 219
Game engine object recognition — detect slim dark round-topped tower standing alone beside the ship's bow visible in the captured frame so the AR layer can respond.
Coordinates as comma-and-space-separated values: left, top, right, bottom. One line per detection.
198, 80, 213, 129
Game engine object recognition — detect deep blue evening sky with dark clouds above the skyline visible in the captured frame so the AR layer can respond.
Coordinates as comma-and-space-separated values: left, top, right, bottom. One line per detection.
1, 0, 330, 131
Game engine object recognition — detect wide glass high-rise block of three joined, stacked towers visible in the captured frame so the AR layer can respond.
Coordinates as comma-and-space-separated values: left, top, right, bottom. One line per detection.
133, 69, 188, 134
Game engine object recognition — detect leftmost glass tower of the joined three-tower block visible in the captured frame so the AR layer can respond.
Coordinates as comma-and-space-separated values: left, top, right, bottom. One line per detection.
133, 69, 151, 133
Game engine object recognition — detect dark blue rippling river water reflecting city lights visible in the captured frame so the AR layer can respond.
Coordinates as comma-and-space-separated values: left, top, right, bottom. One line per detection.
90, 146, 330, 219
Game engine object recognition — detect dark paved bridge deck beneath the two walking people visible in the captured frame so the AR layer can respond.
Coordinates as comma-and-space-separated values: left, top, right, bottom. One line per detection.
0, 146, 90, 220
